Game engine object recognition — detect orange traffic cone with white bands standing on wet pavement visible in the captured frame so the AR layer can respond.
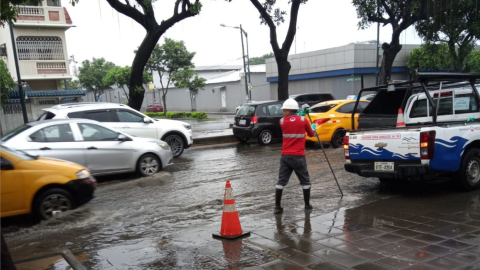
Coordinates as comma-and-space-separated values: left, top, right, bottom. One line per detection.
213, 181, 250, 239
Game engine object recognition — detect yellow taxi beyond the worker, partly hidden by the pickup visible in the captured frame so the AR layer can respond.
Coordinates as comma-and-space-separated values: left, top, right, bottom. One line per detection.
306, 100, 369, 148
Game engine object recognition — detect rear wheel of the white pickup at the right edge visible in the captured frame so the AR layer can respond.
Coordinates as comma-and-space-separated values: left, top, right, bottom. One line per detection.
459, 148, 480, 191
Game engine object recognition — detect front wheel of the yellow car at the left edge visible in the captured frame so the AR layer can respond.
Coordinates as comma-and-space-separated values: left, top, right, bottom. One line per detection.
33, 188, 75, 220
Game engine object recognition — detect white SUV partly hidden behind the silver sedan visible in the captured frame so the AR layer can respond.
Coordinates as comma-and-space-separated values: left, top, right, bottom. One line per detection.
37, 102, 193, 157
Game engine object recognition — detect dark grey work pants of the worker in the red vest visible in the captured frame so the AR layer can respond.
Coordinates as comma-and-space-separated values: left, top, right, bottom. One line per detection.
276, 155, 312, 189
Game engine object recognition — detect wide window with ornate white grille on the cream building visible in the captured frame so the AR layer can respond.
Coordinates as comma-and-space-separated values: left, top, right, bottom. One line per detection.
17, 37, 65, 60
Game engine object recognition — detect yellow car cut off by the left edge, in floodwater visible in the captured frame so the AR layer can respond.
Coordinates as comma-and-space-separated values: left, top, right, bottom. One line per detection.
0, 146, 97, 219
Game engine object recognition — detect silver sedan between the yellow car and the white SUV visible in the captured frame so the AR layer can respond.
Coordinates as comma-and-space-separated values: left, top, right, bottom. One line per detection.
0, 119, 173, 176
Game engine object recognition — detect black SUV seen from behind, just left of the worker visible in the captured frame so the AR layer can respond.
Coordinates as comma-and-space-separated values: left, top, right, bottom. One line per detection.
233, 101, 283, 145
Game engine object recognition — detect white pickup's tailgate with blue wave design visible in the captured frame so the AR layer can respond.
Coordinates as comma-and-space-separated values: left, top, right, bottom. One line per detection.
349, 130, 420, 162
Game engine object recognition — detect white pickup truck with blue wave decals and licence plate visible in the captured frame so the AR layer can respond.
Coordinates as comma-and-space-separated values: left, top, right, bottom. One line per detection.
344, 75, 480, 190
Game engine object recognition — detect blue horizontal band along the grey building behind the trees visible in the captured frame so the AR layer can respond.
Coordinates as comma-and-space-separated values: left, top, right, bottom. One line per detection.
267, 67, 409, 82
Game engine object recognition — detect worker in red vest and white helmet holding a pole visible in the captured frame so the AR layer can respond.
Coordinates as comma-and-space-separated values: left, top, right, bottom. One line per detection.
274, 98, 316, 214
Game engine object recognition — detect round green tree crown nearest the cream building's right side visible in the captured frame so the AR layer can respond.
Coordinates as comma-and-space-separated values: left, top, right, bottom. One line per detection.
78, 58, 115, 101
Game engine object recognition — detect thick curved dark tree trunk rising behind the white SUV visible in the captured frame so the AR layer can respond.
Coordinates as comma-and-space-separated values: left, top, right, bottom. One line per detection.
128, 31, 165, 111
